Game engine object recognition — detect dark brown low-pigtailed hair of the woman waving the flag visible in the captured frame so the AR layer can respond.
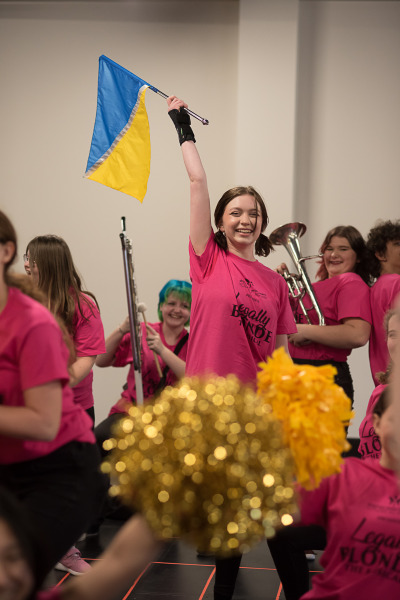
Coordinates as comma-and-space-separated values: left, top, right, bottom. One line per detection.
214, 185, 274, 256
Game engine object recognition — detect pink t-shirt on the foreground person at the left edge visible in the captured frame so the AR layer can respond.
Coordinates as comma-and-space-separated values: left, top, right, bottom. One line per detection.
0, 288, 95, 464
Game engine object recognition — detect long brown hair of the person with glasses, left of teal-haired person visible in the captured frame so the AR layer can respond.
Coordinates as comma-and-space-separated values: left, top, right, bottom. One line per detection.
26, 235, 99, 333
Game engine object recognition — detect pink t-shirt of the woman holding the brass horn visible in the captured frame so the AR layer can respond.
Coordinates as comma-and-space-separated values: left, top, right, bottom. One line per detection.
289, 273, 371, 362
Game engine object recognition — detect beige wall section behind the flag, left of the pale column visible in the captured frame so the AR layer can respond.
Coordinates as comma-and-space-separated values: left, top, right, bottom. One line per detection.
0, 0, 238, 419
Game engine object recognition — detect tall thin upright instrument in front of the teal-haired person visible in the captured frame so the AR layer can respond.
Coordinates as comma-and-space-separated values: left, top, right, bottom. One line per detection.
119, 217, 143, 405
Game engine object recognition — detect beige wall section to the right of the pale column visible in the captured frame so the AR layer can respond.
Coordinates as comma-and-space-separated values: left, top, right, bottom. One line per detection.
293, 1, 400, 436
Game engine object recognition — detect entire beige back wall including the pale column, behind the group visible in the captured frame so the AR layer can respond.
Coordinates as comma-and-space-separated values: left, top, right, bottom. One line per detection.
0, 0, 400, 434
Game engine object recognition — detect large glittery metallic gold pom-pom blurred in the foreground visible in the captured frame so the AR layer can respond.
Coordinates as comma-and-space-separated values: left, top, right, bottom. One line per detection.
103, 376, 296, 555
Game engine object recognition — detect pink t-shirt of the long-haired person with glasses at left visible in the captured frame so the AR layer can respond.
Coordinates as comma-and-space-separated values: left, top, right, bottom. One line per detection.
72, 296, 106, 410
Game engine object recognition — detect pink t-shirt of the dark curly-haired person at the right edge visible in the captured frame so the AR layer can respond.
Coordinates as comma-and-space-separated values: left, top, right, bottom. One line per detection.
369, 274, 400, 385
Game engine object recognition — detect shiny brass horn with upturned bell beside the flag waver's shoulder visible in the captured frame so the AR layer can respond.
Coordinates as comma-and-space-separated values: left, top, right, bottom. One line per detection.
269, 223, 325, 325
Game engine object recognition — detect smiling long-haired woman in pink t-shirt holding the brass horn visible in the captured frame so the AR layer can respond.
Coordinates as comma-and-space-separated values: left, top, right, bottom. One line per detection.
289, 225, 372, 400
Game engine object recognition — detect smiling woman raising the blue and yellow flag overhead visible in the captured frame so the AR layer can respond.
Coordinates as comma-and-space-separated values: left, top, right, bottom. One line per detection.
167, 96, 296, 600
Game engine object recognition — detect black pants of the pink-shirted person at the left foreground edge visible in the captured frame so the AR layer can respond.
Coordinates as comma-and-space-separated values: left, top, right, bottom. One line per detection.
0, 442, 105, 579
